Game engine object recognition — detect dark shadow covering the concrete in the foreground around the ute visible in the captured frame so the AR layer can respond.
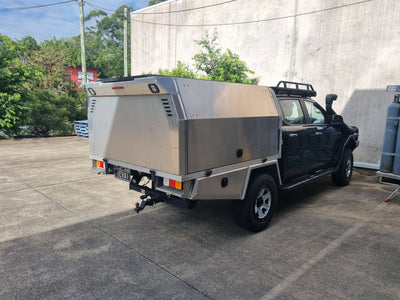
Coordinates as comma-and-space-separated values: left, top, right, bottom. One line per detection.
0, 169, 400, 299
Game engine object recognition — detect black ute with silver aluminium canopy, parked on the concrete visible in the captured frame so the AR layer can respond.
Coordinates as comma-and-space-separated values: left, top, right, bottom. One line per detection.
87, 75, 358, 232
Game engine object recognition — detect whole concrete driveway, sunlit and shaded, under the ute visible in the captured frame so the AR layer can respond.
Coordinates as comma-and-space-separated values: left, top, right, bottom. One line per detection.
0, 137, 400, 299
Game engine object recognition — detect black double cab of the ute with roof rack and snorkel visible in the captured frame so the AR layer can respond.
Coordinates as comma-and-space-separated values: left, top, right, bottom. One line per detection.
272, 81, 358, 189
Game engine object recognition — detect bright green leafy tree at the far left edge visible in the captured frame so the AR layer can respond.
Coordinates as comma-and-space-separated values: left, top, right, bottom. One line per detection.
0, 35, 33, 136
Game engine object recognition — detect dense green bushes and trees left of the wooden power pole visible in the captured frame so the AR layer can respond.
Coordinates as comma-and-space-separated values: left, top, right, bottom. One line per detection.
0, 35, 86, 137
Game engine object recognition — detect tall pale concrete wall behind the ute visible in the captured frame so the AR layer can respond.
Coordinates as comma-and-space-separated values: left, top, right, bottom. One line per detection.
131, 0, 400, 166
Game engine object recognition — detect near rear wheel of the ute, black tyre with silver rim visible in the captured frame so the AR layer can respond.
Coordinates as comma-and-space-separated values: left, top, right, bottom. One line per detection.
233, 174, 278, 232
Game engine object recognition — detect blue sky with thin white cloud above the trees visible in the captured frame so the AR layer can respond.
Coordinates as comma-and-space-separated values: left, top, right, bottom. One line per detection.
0, 0, 149, 42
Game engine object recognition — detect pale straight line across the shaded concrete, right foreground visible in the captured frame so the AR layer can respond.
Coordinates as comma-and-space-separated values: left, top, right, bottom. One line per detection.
261, 224, 362, 300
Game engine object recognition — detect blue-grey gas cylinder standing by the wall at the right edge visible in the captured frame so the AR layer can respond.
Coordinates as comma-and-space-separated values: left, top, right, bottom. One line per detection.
379, 97, 400, 174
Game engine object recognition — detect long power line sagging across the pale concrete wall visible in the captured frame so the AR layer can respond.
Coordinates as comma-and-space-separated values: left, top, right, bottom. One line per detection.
132, 0, 374, 27
